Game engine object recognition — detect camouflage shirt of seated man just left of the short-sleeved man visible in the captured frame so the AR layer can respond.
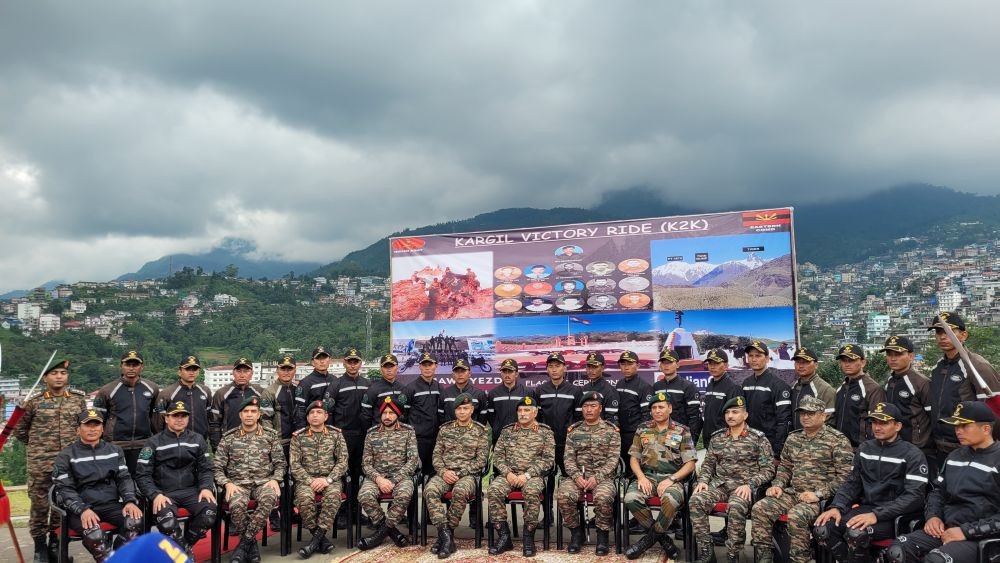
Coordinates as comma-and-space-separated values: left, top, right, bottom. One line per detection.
563, 420, 622, 481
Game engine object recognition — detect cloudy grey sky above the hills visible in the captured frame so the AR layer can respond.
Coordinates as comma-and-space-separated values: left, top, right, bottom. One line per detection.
0, 0, 1000, 292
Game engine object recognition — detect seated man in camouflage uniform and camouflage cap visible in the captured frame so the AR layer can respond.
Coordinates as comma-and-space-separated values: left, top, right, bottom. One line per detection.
751, 396, 854, 563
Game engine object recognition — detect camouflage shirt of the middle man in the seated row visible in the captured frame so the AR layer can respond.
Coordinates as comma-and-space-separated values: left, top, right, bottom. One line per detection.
493, 422, 556, 477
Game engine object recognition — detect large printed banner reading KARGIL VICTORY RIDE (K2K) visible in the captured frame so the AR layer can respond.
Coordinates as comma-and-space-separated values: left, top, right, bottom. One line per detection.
390, 208, 797, 389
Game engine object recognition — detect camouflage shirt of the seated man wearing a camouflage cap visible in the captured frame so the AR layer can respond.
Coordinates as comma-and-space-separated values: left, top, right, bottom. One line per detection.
771, 425, 854, 499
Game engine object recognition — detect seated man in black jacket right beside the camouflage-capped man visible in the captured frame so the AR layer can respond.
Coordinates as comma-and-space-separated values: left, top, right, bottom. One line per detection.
813, 403, 927, 563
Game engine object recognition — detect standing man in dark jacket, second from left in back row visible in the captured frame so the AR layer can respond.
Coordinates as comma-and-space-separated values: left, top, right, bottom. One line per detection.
94, 350, 160, 472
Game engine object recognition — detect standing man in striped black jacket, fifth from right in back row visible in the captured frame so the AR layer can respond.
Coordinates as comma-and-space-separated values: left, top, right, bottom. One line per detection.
743, 340, 792, 458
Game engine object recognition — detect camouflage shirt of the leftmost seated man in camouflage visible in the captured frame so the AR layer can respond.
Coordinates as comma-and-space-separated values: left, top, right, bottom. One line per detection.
214, 424, 285, 487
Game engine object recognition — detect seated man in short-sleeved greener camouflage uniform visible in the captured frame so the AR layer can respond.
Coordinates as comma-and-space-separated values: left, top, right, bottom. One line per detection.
625, 390, 698, 559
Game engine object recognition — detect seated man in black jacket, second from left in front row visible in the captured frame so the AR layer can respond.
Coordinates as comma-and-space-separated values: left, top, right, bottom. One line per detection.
135, 401, 218, 557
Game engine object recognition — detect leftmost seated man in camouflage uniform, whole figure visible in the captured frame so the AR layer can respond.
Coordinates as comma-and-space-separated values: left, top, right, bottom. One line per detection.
214, 395, 287, 563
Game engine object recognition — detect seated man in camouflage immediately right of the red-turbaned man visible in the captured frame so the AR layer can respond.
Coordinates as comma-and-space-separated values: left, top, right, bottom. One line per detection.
424, 393, 490, 559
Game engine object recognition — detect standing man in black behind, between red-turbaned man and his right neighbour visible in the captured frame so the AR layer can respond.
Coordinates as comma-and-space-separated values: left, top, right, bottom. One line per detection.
403, 352, 444, 475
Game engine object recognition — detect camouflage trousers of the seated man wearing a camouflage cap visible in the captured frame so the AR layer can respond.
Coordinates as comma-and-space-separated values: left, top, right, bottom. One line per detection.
750, 491, 819, 563
